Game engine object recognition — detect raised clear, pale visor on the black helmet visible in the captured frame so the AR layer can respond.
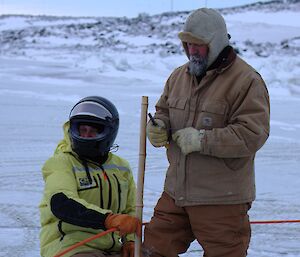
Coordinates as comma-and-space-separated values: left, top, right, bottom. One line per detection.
70, 101, 113, 120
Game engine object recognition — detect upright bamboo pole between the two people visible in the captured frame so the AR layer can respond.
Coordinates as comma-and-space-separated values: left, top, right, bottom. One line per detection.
134, 96, 148, 257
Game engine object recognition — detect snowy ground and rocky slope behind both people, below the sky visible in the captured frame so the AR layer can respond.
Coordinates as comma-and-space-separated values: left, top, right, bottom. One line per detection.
0, 1, 300, 257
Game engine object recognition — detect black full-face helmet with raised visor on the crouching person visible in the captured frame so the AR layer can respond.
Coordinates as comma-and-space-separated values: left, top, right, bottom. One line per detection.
69, 96, 119, 160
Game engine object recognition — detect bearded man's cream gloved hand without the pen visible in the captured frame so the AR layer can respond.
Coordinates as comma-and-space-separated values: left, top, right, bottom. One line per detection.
172, 127, 205, 155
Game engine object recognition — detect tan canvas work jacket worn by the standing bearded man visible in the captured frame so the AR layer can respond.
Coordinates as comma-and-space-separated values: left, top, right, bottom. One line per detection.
155, 50, 270, 206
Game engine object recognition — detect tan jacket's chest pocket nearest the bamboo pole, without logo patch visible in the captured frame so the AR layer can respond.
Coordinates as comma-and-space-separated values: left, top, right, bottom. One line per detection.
167, 98, 187, 133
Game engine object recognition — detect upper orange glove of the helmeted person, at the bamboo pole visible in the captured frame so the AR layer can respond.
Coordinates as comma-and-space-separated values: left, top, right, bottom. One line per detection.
104, 214, 142, 237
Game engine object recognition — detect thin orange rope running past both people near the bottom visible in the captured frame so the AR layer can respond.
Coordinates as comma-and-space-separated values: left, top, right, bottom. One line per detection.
54, 220, 300, 257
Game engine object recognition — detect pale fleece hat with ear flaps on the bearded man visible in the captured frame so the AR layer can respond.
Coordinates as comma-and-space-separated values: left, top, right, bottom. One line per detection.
178, 8, 229, 67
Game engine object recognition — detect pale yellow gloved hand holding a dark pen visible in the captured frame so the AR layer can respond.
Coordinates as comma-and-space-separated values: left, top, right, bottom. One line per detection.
147, 119, 168, 147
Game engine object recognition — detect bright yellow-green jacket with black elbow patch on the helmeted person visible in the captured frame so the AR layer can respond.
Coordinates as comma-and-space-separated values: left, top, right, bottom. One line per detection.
39, 122, 136, 257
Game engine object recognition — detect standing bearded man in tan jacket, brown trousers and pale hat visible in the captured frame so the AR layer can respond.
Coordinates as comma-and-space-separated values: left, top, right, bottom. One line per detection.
143, 8, 270, 257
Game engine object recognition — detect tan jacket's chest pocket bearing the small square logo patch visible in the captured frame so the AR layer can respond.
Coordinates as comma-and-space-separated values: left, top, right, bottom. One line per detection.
196, 101, 227, 129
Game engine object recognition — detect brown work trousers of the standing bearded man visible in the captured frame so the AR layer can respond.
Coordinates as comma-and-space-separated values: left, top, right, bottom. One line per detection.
143, 192, 251, 257
